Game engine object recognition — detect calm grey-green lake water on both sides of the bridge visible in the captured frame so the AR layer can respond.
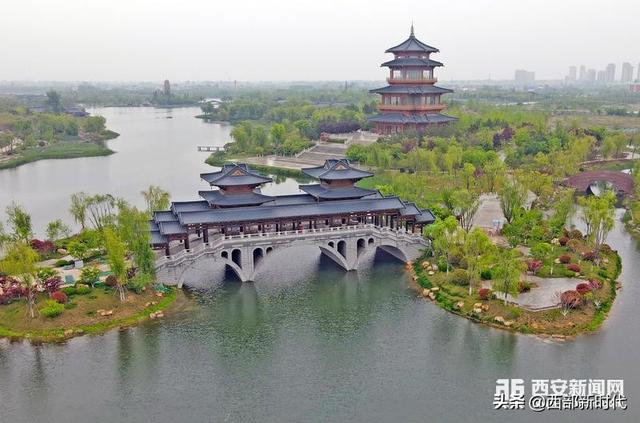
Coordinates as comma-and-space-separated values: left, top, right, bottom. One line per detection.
0, 109, 640, 423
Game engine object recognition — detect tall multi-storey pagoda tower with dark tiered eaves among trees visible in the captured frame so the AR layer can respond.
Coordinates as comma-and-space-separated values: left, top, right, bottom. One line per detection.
369, 25, 456, 135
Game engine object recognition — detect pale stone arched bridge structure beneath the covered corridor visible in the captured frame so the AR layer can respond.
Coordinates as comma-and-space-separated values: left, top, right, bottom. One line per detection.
156, 224, 428, 287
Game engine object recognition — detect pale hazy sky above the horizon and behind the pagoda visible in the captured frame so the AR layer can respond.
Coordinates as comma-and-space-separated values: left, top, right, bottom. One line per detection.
0, 0, 640, 81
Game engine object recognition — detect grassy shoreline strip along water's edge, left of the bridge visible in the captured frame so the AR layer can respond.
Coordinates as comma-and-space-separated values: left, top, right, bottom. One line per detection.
0, 288, 189, 344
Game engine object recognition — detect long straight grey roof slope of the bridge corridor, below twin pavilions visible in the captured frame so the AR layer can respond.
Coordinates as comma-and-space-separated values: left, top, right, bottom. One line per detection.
176, 197, 404, 227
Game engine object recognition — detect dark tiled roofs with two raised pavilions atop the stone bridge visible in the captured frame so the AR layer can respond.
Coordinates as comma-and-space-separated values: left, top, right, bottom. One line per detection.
150, 159, 435, 248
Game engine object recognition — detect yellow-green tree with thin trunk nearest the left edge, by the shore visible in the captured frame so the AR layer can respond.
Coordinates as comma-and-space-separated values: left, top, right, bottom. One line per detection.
0, 241, 39, 318
